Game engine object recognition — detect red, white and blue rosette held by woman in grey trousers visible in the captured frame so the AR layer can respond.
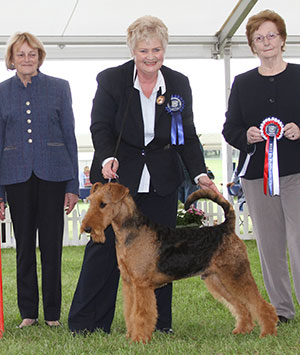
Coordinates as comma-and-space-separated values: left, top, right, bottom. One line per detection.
260, 117, 284, 196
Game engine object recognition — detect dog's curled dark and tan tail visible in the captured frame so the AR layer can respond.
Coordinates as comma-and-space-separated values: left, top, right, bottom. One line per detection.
184, 189, 235, 233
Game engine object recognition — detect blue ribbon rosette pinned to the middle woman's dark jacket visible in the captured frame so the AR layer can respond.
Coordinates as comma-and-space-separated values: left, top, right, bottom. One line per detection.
166, 95, 184, 145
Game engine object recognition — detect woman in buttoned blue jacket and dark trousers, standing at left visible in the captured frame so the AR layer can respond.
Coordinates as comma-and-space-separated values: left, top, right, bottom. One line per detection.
0, 32, 78, 328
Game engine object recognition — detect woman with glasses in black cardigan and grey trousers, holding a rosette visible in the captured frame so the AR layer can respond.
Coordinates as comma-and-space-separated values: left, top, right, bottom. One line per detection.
223, 10, 300, 322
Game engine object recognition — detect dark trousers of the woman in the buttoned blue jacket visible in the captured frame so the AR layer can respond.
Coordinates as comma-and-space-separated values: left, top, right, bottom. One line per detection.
5, 174, 66, 320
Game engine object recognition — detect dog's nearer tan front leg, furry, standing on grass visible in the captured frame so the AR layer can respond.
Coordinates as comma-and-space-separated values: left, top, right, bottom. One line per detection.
130, 285, 157, 343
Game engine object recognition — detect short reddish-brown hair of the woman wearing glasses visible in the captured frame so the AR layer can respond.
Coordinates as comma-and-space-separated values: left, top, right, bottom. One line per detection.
246, 10, 287, 54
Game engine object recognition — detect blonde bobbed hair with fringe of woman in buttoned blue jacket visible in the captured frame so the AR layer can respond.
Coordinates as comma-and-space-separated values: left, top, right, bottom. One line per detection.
5, 32, 46, 70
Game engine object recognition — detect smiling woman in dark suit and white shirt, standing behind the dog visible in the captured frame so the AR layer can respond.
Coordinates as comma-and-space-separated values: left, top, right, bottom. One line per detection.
69, 16, 217, 333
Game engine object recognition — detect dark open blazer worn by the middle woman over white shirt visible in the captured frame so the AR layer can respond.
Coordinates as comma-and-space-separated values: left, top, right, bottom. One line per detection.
91, 60, 206, 196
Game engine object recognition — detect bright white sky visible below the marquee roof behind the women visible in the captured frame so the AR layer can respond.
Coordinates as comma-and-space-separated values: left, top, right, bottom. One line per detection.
0, 58, 258, 135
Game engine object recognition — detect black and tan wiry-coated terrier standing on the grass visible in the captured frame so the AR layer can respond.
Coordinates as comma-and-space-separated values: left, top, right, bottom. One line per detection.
81, 183, 278, 343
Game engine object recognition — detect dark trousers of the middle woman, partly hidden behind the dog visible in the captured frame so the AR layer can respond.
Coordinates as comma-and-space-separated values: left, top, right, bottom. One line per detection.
68, 191, 178, 333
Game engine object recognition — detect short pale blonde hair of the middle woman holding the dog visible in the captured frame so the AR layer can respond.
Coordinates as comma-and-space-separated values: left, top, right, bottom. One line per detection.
127, 16, 168, 54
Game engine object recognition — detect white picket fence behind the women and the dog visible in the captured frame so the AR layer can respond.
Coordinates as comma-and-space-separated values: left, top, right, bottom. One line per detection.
0, 201, 254, 248
